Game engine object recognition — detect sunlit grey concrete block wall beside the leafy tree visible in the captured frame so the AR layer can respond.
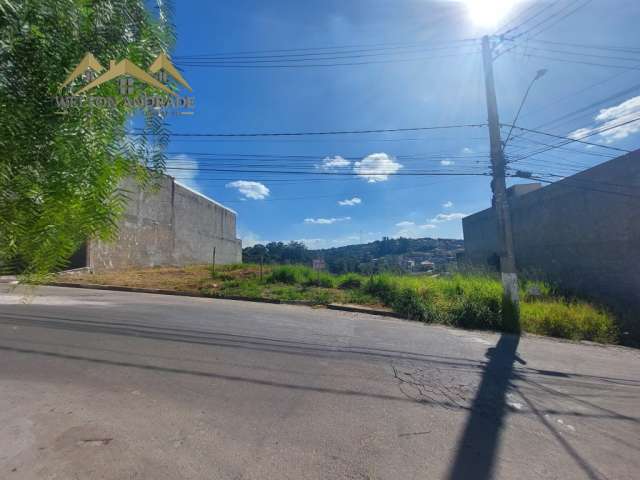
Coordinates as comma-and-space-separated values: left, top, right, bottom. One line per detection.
88, 177, 242, 270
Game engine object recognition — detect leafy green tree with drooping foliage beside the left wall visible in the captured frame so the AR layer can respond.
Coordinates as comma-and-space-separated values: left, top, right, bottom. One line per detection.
0, 0, 174, 275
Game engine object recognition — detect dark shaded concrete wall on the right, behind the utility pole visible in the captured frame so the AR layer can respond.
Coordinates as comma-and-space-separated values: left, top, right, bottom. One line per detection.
462, 150, 640, 311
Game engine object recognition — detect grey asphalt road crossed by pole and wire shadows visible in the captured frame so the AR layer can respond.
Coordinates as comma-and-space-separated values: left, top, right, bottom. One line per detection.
0, 285, 640, 480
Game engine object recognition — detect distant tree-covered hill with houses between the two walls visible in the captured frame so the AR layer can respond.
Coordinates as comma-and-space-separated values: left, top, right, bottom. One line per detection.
243, 237, 464, 273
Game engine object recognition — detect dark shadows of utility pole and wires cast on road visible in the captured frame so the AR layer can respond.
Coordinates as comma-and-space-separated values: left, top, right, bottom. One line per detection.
0, 313, 640, 480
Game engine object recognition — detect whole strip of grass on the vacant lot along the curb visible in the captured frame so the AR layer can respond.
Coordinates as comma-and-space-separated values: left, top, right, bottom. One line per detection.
58, 264, 617, 343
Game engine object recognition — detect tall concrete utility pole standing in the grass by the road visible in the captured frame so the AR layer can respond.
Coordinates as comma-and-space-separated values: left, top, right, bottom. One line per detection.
482, 35, 519, 306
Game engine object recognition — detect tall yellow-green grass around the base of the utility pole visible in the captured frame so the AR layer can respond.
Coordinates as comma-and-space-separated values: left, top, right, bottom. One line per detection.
363, 275, 617, 343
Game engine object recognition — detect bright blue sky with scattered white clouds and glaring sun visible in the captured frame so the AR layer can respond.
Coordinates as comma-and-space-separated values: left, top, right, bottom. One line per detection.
159, 0, 640, 248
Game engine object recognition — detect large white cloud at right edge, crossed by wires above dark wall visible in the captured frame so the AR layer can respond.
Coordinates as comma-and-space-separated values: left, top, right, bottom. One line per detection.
569, 96, 640, 143
